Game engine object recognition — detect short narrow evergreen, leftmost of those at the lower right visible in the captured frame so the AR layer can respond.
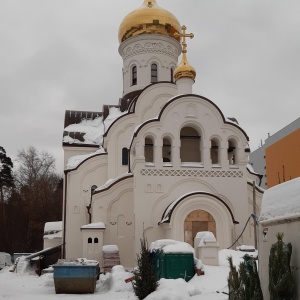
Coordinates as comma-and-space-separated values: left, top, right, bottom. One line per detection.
228, 256, 245, 300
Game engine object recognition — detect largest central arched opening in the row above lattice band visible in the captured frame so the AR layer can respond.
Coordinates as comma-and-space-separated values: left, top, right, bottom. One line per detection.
180, 127, 201, 163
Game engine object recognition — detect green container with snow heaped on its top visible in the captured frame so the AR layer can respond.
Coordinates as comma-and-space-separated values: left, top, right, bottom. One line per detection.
154, 251, 195, 281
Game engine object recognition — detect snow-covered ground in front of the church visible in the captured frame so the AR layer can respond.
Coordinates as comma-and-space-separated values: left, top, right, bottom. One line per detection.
0, 250, 256, 300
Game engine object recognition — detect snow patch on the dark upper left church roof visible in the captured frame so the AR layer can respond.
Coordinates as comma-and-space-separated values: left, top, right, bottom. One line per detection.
63, 117, 104, 145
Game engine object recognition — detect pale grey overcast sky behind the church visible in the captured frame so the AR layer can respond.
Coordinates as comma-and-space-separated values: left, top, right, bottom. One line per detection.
0, 0, 300, 172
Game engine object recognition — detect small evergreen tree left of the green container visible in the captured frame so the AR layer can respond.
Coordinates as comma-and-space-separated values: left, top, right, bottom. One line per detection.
132, 237, 158, 300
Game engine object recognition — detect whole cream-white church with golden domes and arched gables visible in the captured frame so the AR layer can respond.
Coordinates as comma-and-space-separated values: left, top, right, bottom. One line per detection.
63, 0, 262, 267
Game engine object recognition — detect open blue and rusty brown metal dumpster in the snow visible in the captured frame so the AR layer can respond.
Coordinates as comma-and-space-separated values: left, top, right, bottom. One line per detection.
53, 260, 100, 294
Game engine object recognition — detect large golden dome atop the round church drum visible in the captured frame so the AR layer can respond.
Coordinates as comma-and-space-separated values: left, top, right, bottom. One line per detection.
119, 0, 181, 43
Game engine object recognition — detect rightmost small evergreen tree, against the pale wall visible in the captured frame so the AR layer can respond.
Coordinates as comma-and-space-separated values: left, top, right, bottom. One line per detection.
269, 233, 294, 300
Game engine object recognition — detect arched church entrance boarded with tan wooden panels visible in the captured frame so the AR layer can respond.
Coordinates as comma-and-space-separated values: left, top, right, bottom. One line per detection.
184, 210, 217, 247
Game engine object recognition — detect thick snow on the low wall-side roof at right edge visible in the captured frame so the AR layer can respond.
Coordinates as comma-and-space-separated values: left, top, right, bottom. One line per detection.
259, 177, 300, 222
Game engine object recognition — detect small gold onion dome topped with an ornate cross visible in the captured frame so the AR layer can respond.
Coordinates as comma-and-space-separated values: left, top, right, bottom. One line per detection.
174, 25, 196, 81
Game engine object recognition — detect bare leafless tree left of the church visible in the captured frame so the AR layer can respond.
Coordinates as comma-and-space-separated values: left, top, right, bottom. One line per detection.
16, 146, 62, 252
